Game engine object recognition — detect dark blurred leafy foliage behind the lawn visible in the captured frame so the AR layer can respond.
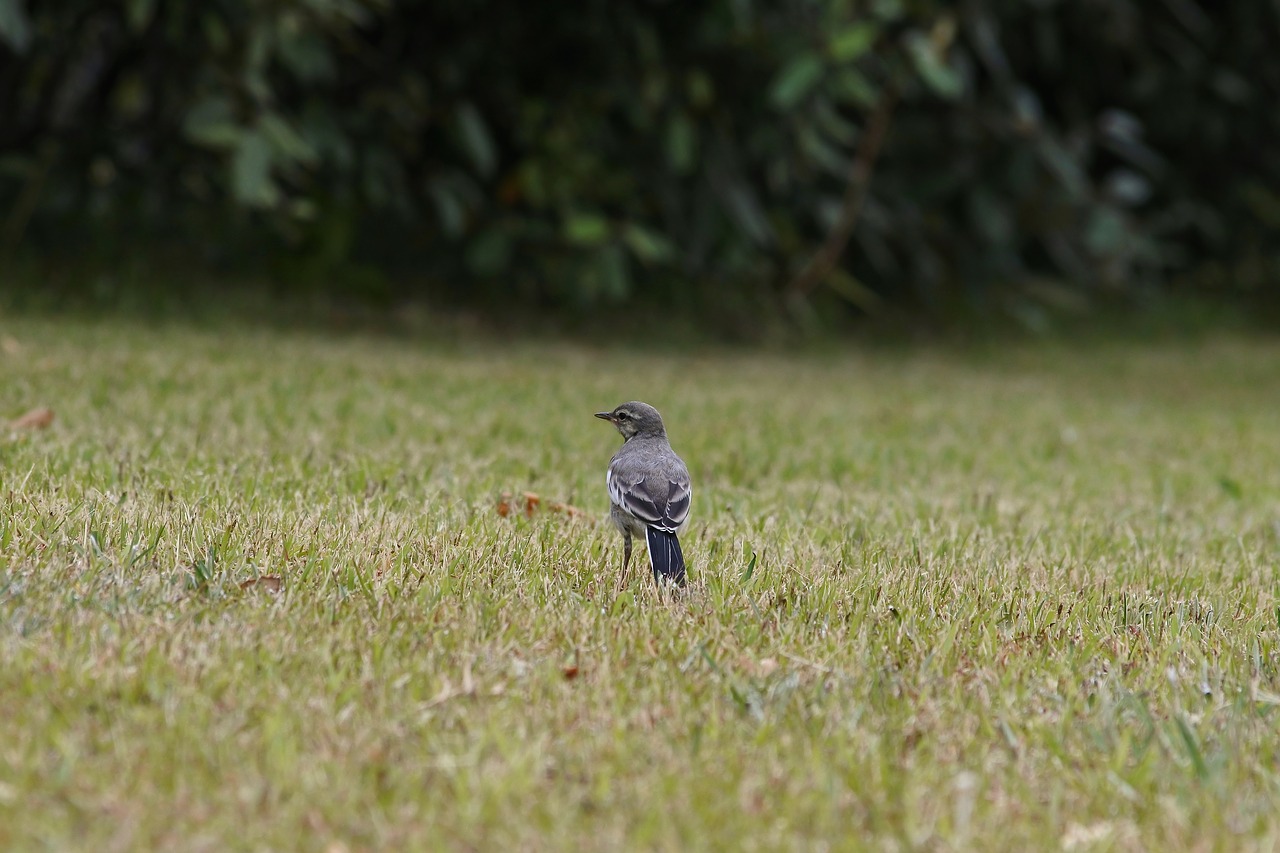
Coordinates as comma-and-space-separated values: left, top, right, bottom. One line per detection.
0, 0, 1280, 325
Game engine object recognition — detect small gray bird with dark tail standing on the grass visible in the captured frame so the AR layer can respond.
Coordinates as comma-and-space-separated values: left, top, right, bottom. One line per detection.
595, 402, 692, 587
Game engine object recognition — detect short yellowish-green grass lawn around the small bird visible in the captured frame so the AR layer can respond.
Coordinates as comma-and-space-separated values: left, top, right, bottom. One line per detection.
0, 319, 1280, 850
